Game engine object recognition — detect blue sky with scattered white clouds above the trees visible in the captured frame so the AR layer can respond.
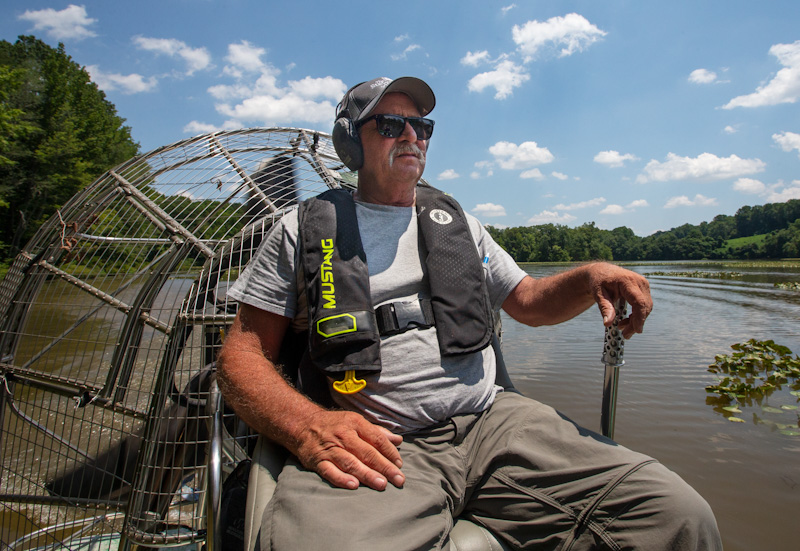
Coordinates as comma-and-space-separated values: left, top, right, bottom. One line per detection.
0, 0, 800, 236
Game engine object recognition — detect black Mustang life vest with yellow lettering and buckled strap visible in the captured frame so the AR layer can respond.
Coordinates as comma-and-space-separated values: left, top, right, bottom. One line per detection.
298, 184, 494, 387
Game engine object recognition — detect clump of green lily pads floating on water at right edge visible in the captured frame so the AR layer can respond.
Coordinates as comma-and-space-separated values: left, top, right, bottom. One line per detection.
706, 339, 800, 436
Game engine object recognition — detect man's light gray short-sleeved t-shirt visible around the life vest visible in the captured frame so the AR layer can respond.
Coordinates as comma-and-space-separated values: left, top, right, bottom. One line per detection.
228, 196, 525, 433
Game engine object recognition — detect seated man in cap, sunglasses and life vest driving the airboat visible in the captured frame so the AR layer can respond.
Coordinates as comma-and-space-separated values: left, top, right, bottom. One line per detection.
219, 77, 721, 550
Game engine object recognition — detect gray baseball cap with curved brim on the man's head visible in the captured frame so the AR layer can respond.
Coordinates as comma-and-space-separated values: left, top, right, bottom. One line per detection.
336, 77, 436, 122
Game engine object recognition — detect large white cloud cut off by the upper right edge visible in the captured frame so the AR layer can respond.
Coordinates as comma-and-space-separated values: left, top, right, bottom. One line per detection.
722, 40, 800, 109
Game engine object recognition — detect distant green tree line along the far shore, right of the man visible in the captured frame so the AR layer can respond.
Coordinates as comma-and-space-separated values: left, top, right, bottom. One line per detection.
487, 199, 800, 262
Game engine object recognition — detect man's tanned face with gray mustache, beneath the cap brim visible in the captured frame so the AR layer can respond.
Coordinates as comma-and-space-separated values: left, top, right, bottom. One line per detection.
359, 93, 428, 195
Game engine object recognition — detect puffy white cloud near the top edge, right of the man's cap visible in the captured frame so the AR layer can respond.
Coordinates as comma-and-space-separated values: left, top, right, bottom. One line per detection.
511, 13, 607, 60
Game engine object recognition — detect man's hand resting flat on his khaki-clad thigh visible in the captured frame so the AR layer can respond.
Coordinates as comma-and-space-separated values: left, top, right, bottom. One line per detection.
291, 409, 405, 490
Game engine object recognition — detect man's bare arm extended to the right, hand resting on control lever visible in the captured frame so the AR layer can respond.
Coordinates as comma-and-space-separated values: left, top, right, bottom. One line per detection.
503, 262, 653, 338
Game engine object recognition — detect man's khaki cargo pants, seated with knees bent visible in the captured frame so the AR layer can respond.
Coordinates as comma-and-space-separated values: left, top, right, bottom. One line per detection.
259, 392, 722, 551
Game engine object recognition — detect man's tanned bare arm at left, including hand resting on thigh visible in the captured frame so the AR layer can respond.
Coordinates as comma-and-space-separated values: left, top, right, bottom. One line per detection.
217, 304, 404, 490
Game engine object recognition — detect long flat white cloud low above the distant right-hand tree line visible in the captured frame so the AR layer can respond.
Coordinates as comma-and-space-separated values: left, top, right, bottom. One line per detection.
636, 153, 767, 184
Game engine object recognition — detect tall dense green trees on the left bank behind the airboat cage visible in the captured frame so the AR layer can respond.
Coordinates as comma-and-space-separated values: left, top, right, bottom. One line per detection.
0, 36, 139, 260
